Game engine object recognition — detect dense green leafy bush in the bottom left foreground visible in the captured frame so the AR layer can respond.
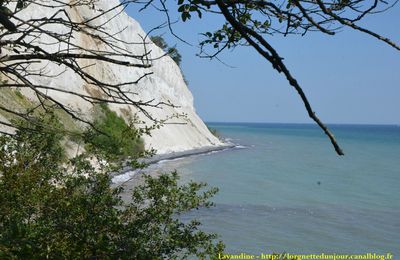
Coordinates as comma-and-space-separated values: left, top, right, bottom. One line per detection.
0, 117, 223, 259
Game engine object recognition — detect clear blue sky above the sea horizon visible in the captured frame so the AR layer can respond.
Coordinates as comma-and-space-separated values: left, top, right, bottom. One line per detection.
127, 1, 400, 125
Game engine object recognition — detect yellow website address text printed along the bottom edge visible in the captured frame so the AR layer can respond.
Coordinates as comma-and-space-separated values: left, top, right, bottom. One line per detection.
218, 253, 393, 260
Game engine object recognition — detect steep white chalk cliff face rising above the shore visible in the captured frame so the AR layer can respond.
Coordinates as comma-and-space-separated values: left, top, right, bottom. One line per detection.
1, 0, 221, 154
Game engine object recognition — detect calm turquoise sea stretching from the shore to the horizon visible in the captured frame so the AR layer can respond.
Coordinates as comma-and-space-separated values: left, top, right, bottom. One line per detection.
158, 123, 400, 259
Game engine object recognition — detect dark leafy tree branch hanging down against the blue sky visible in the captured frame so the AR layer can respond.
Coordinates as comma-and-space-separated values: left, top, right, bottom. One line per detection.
168, 0, 400, 155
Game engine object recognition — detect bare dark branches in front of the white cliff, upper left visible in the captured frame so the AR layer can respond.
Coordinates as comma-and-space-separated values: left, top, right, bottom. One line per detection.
0, 0, 164, 138
